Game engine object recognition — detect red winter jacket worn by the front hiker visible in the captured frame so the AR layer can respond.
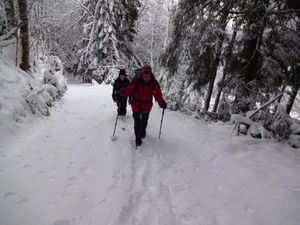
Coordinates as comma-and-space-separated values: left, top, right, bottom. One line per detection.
124, 72, 165, 113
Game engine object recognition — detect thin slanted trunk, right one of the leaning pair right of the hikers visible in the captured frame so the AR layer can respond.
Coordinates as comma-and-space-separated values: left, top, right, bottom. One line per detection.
213, 29, 237, 112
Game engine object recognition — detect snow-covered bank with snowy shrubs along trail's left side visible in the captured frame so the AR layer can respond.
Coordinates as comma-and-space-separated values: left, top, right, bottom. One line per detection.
0, 46, 67, 139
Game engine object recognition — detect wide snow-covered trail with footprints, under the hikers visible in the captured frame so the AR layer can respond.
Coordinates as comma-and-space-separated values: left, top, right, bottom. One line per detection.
0, 85, 300, 225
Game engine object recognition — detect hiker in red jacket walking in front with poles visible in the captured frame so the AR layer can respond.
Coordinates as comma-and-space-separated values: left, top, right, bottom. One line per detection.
124, 64, 167, 146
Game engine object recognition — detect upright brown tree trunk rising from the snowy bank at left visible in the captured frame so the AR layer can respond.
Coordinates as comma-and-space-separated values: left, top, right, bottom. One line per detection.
18, 0, 30, 71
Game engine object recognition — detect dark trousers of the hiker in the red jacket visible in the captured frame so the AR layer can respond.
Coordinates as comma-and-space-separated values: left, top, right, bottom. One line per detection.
132, 112, 149, 140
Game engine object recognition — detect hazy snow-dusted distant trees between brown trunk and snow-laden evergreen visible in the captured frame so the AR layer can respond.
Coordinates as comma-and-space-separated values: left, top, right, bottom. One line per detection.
29, 0, 83, 72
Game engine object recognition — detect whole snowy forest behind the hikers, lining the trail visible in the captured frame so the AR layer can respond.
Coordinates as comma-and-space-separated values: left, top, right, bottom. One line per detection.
0, 0, 300, 144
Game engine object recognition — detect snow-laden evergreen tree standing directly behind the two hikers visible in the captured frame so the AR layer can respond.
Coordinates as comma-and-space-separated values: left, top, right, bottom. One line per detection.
78, 0, 140, 82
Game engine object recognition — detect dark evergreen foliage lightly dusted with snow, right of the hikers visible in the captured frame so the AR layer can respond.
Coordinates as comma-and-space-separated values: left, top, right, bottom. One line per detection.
161, 0, 300, 117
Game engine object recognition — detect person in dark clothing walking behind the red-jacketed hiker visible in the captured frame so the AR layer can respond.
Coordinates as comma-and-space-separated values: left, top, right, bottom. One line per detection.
112, 69, 130, 116
